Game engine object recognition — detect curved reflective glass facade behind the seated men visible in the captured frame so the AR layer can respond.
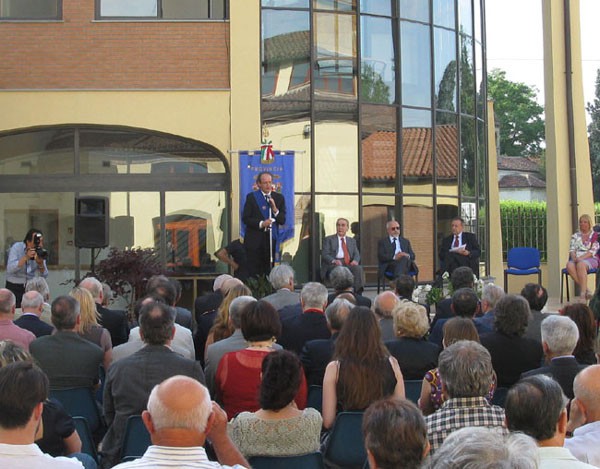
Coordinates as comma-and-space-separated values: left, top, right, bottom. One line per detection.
261, 0, 488, 282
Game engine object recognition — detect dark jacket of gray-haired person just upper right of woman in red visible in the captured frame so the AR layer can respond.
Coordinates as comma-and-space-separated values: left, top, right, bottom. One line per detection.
277, 309, 331, 355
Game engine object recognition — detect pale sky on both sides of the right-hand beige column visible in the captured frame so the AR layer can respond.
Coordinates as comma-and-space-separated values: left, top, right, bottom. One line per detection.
486, 0, 600, 115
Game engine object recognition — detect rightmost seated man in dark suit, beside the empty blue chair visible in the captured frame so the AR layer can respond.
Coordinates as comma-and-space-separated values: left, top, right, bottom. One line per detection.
439, 217, 481, 278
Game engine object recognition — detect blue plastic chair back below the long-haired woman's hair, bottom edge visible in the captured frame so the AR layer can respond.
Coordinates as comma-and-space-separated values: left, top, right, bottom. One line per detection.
323, 412, 367, 468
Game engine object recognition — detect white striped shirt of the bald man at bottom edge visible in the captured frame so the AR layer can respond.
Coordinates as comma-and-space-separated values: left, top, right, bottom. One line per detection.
114, 445, 245, 469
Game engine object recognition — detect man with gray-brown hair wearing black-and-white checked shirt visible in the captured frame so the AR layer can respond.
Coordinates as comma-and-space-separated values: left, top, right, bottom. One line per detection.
425, 340, 506, 453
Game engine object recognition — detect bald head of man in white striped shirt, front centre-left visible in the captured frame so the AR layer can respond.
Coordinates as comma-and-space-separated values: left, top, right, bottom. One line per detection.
143, 375, 212, 446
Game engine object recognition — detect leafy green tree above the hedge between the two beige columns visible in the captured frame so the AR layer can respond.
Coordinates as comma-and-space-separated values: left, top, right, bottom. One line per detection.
488, 69, 545, 156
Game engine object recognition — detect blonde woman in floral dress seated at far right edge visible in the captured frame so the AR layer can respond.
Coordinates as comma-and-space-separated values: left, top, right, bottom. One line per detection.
567, 214, 600, 301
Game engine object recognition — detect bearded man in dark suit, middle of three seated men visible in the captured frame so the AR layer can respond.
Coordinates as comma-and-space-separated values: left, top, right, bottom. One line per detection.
377, 220, 415, 280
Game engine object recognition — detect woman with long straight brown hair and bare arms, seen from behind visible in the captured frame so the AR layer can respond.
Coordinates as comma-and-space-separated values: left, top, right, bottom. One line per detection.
322, 306, 405, 429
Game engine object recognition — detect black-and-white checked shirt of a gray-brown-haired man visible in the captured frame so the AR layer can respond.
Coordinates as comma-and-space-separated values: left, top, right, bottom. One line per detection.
425, 397, 508, 453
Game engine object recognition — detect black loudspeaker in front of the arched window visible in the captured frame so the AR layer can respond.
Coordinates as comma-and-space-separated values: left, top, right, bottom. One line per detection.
75, 196, 109, 248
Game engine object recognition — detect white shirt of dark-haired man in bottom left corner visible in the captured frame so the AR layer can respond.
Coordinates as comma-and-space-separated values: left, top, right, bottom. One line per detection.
0, 443, 83, 469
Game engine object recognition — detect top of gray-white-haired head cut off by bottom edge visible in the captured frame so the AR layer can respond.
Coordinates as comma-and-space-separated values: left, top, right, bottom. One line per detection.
427, 427, 539, 469
